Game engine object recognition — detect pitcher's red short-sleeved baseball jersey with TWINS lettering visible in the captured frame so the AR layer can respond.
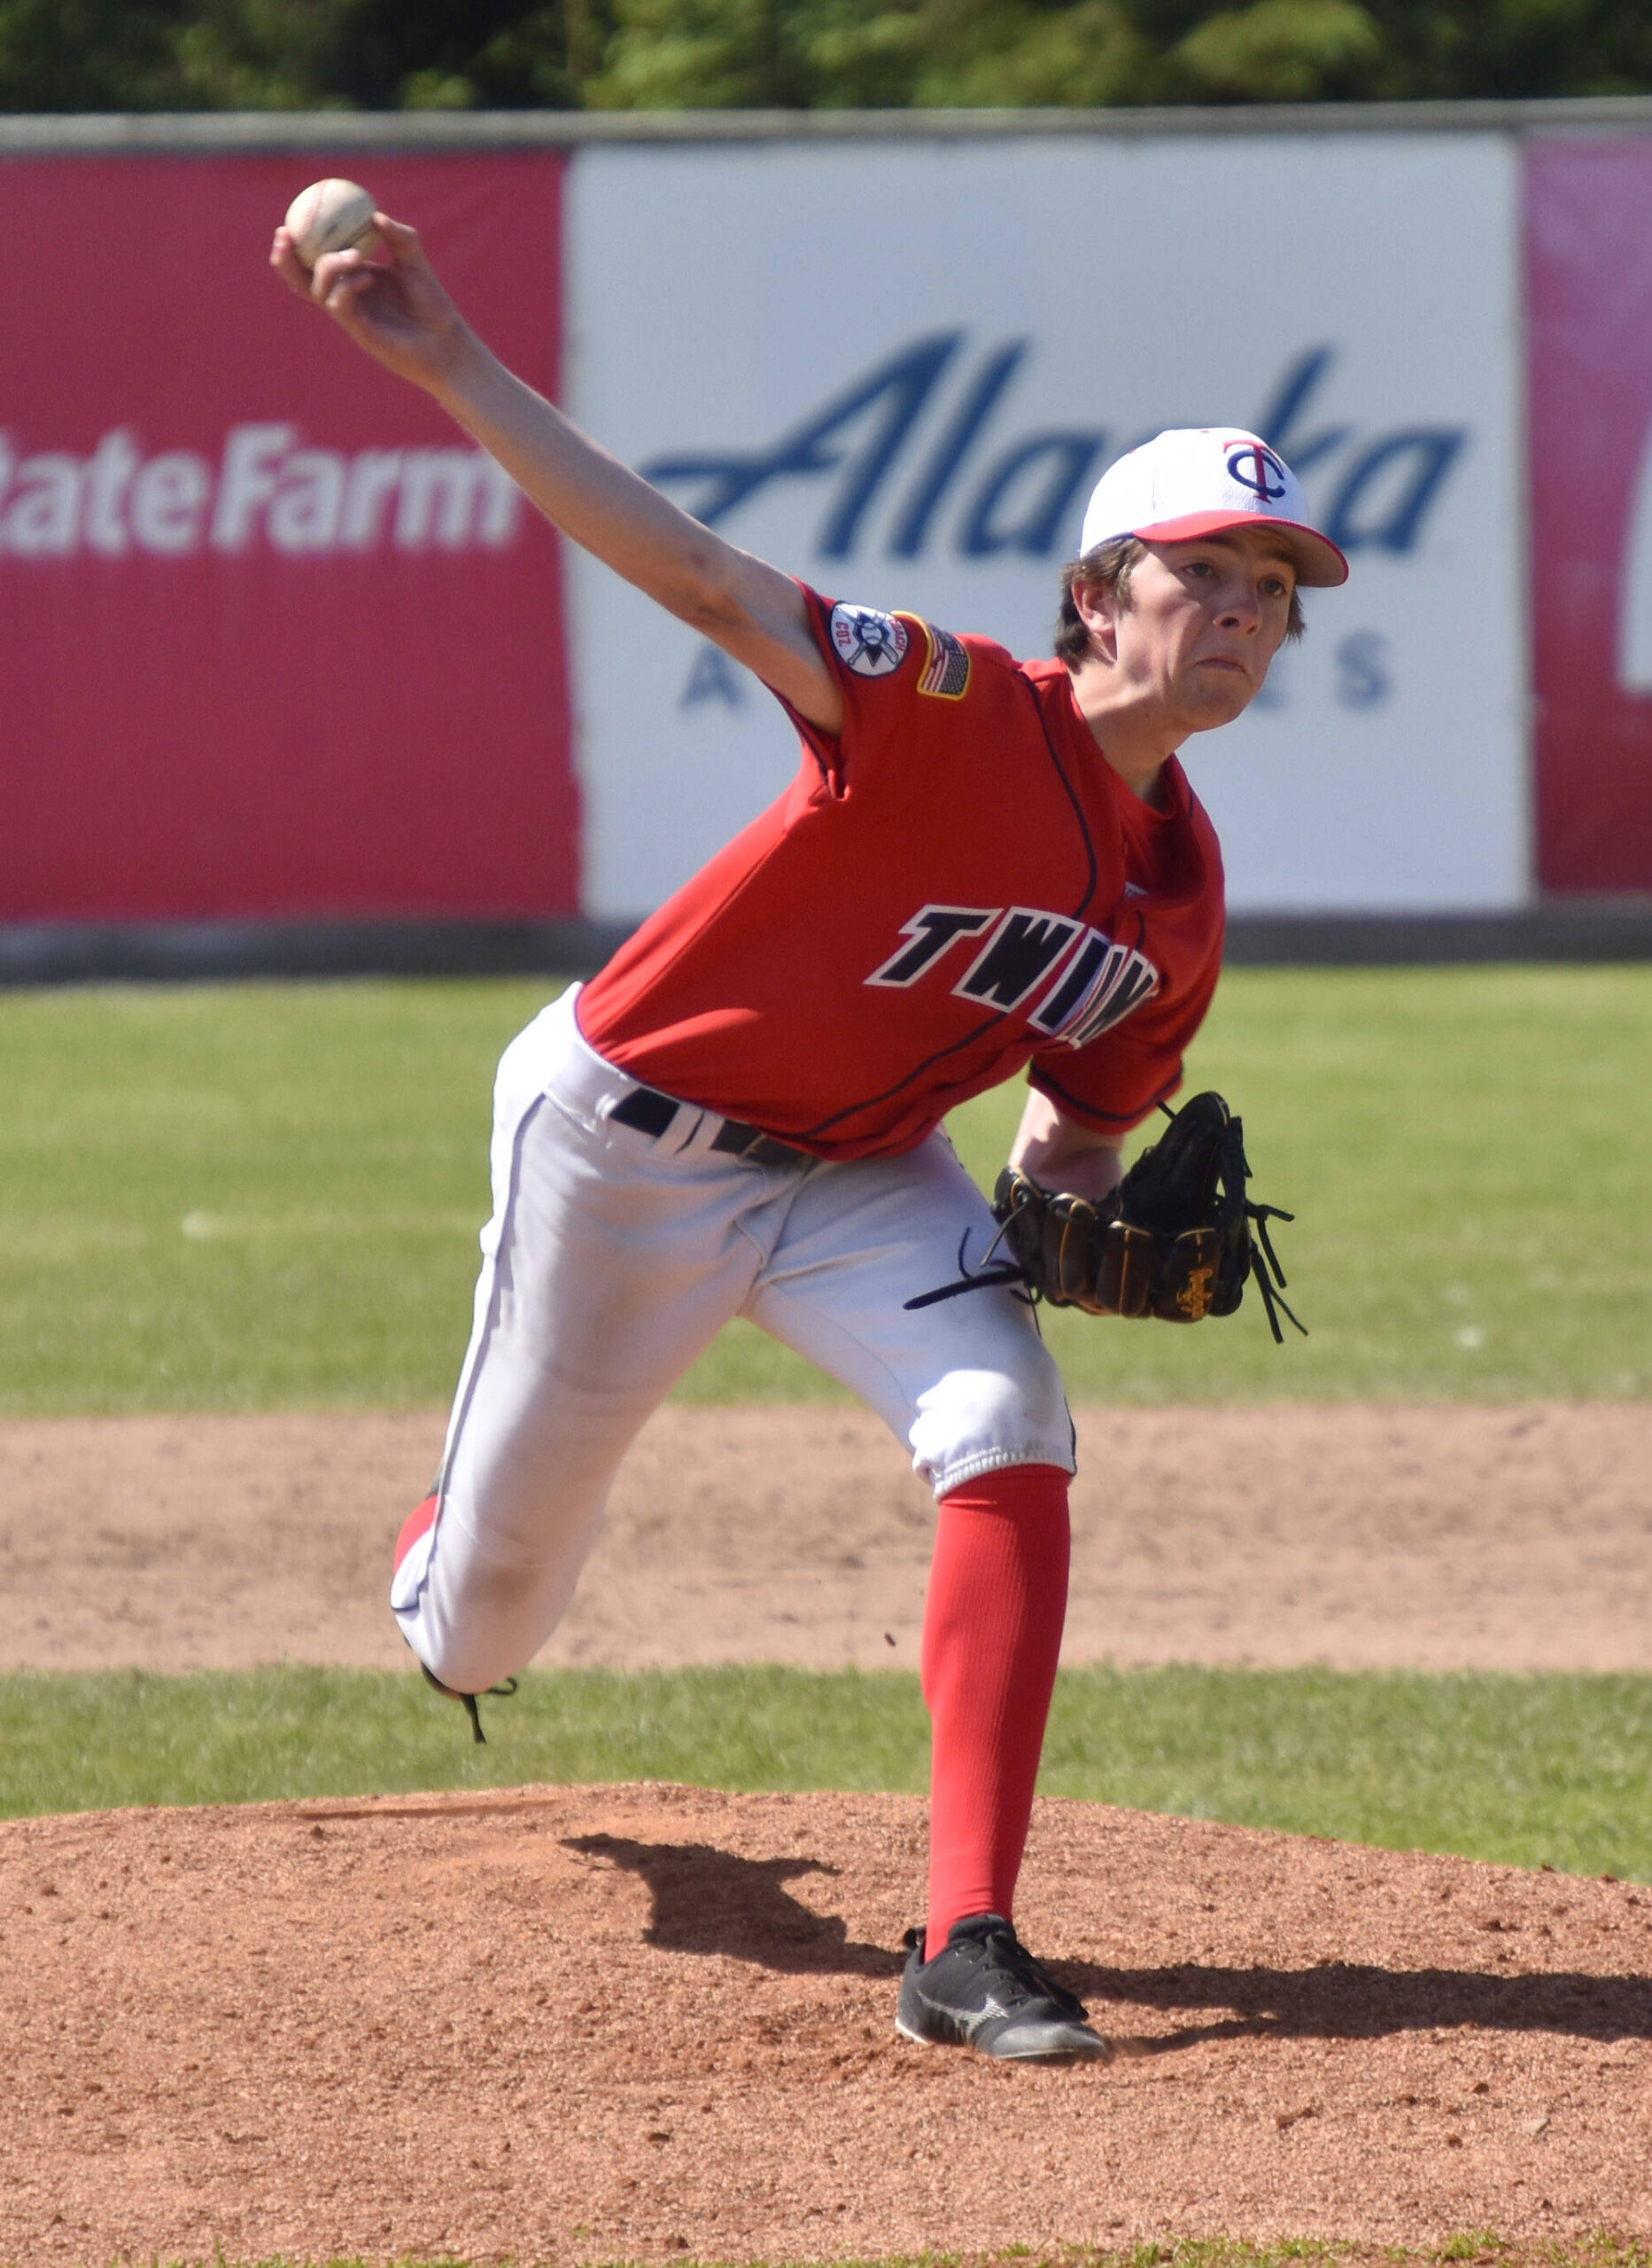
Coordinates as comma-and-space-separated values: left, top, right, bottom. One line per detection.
578, 592, 1223, 1157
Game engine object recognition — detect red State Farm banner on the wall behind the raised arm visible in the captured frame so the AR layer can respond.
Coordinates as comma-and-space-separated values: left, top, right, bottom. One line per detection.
0, 150, 580, 923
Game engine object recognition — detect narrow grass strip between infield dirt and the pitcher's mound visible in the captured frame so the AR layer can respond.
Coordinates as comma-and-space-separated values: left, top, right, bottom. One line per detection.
12, 1665, 1652, 1880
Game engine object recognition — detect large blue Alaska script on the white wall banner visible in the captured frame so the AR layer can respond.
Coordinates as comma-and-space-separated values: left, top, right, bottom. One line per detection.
641, 331, 1469, 560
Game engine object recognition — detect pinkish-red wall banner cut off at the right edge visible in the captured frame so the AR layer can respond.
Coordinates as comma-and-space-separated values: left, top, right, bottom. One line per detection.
1525, 141, 1652, 891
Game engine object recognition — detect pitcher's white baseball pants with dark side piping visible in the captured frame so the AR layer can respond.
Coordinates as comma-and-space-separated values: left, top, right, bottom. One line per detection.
390, 989, 1074, 1692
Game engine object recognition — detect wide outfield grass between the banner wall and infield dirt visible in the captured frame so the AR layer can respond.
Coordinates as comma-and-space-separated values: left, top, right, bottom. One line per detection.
0, 967, 1652, 1413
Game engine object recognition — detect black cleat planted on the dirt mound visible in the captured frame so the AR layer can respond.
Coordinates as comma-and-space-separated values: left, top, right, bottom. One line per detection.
896, 1915, 1113, 2064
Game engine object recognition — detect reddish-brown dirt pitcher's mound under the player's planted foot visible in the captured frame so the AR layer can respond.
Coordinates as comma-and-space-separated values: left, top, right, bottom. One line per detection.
0, 1787, 1652, 2264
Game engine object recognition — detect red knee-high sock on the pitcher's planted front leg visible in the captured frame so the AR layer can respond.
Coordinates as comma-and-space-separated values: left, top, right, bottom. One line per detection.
922, 1465, 1070, 1960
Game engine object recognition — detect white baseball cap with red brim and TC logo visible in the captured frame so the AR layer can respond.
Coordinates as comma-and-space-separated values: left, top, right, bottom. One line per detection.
1079, 426, 1348, 585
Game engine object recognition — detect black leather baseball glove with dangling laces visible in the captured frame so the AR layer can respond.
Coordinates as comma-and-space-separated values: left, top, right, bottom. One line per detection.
993, 1093, 1303, 1343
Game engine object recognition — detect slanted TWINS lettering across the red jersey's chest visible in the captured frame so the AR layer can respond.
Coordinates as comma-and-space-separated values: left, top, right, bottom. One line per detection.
865, 905, 1158, 1048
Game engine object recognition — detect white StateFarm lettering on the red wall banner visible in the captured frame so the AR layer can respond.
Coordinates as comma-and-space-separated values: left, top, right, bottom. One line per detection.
0, 422, 521, 560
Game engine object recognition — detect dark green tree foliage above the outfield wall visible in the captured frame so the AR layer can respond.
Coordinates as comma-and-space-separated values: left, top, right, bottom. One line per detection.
0, 0, 1652, 111
